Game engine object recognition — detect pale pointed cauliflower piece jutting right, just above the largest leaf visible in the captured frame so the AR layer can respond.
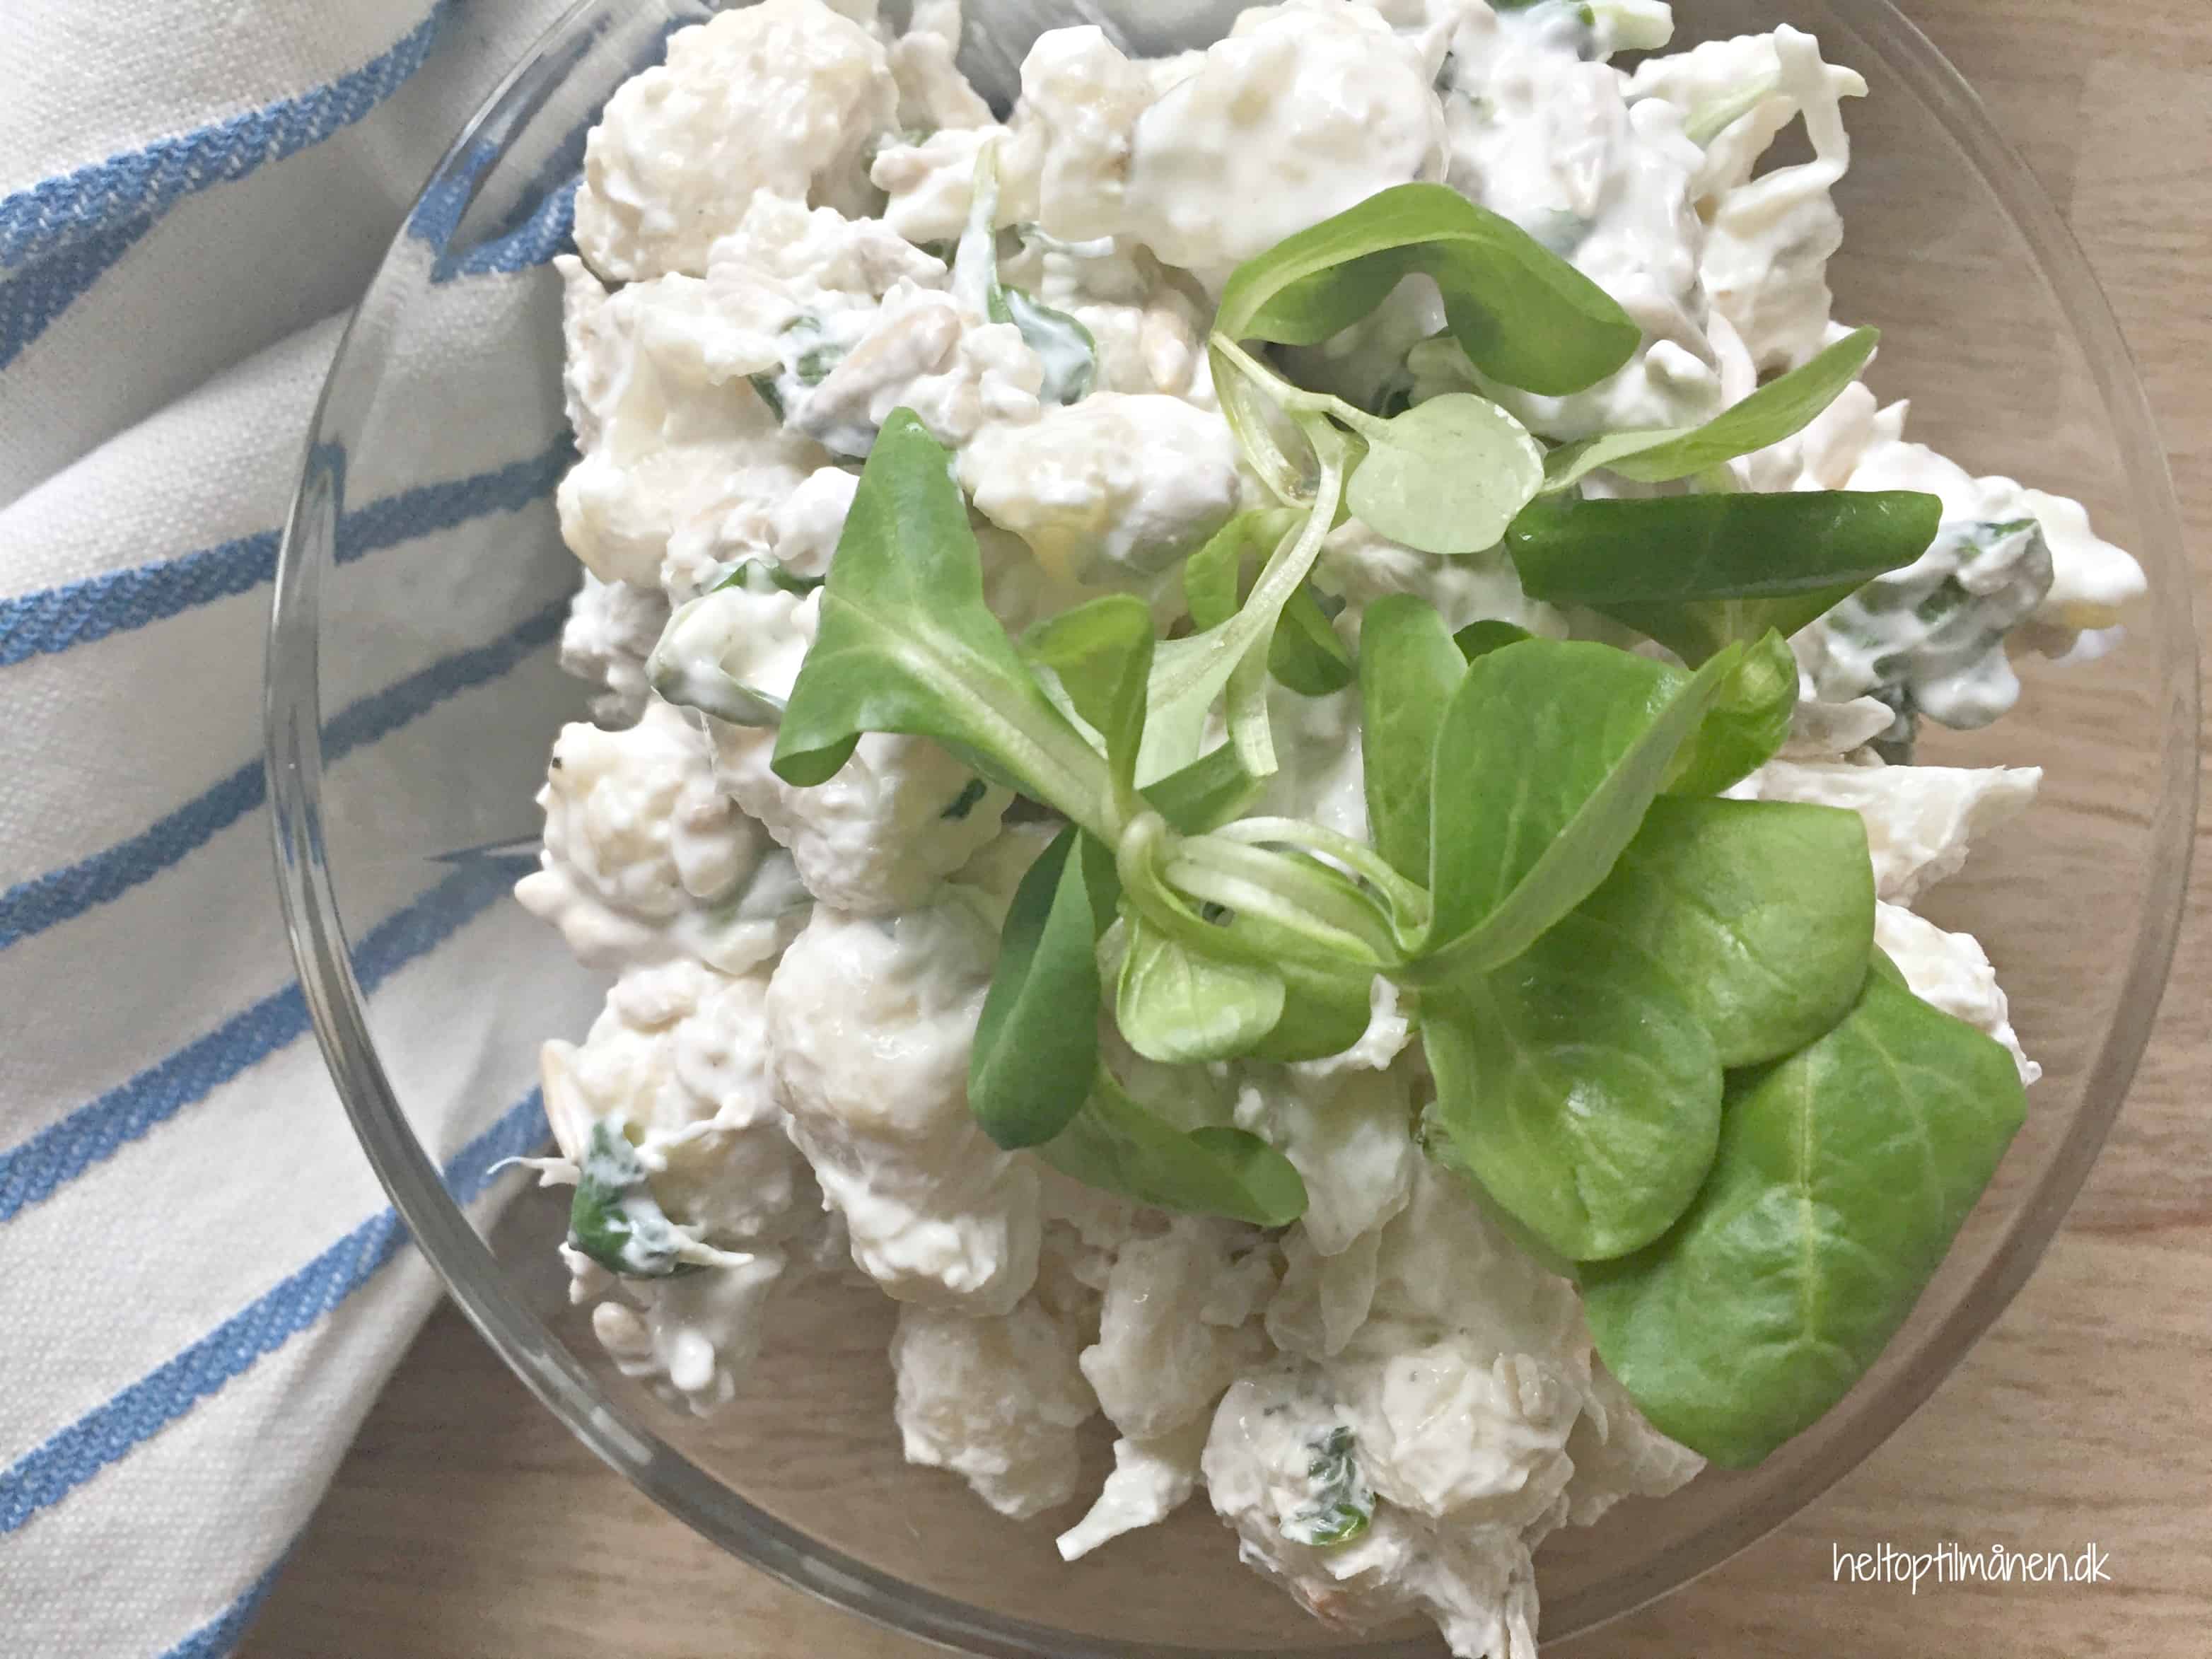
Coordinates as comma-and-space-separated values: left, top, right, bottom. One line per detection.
1734, 761, 2044, 904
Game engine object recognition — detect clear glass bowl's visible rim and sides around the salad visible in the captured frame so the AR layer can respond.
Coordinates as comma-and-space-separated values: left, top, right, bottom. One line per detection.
267, 0, 2196, 1659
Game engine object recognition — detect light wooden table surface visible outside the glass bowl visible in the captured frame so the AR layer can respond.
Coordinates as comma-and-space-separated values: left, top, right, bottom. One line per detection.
246, 0, 2212, 1659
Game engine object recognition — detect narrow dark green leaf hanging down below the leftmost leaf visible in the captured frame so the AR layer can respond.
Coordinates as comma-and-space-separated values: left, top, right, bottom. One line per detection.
969, 825, 1119, 1148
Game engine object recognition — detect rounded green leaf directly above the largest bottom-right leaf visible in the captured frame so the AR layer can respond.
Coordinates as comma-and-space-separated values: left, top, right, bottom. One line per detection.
1577, 796, 1873, 1069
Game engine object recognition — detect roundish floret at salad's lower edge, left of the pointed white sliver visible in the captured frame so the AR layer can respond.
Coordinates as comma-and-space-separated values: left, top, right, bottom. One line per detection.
892, 1296, 1097, 1520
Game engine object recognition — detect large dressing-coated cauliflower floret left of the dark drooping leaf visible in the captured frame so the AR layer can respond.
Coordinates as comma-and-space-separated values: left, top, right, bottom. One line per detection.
767, 889, 1042, 1314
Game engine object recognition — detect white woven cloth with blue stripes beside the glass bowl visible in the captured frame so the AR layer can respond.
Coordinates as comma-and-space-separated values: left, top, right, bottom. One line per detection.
0, 0, 593, 1659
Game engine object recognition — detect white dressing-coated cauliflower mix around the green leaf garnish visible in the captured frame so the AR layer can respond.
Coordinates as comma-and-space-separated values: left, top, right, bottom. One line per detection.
518, 0, 2141, 1659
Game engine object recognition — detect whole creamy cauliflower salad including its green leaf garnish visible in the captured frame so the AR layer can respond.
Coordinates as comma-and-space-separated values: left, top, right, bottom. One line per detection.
518, 0, 2141, 1659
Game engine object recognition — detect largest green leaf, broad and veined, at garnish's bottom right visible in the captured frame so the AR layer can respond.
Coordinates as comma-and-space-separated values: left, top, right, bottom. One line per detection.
1582, 971, 2026, 1469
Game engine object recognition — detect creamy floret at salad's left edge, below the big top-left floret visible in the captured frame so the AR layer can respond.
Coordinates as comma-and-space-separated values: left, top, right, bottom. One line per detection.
555, 259, 830, 588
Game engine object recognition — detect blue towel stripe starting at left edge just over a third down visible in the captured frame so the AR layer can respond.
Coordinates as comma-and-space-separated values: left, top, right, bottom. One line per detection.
0, 438, 575, 668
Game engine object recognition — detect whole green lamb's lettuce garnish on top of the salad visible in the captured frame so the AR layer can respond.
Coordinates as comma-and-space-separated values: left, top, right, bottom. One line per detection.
743, 186, 2018, 1460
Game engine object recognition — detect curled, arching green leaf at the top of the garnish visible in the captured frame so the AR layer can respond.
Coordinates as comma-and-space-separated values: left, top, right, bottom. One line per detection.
1214, 184, 1643, 396
